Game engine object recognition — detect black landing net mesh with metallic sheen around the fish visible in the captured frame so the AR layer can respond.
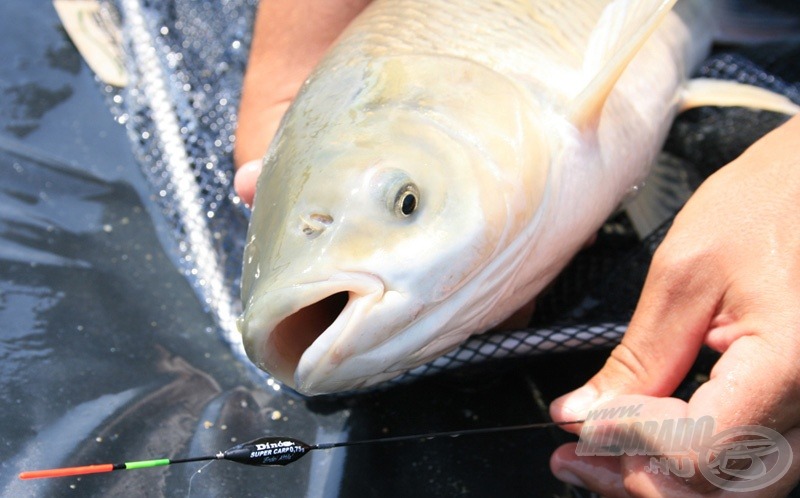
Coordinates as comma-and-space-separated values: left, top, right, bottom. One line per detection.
98, 0, 800, 390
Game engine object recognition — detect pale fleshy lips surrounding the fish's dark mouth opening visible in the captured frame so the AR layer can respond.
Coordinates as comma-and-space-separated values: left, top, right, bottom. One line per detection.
242, 271, 385, 392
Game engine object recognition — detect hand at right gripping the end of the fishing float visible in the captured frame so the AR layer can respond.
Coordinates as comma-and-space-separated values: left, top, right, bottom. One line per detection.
551, 116, 800, 497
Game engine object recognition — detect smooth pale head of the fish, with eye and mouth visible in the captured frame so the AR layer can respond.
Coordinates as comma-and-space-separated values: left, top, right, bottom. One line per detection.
239, 58, 547, 394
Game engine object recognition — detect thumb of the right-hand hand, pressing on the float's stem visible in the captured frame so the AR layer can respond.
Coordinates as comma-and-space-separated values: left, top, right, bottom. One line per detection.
550, 245, 721, 424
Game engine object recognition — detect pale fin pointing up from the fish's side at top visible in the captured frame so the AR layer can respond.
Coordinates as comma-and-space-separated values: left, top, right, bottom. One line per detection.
570, 0, 676, 128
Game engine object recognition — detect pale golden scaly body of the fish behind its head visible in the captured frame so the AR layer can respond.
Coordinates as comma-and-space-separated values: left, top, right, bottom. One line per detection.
328, 0, 602, 98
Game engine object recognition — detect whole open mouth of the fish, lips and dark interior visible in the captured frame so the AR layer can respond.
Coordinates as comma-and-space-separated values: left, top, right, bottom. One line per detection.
241, 272, 384, 393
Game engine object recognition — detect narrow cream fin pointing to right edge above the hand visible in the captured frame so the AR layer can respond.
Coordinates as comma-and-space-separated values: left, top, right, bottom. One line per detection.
680, 78, 800, 115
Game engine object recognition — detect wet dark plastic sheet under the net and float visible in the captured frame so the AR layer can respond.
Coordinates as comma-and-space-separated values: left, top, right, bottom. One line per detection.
0, 0, 796, 497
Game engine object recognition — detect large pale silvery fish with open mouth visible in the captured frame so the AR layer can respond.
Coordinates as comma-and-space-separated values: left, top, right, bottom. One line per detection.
237, 0, 790, 395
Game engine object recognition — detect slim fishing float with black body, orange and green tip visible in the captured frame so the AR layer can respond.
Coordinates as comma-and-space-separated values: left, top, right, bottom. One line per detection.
19, 420, 584, 479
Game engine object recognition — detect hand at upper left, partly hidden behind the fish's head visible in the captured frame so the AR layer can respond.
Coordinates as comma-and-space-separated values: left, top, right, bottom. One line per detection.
234, 0, 370, 204
